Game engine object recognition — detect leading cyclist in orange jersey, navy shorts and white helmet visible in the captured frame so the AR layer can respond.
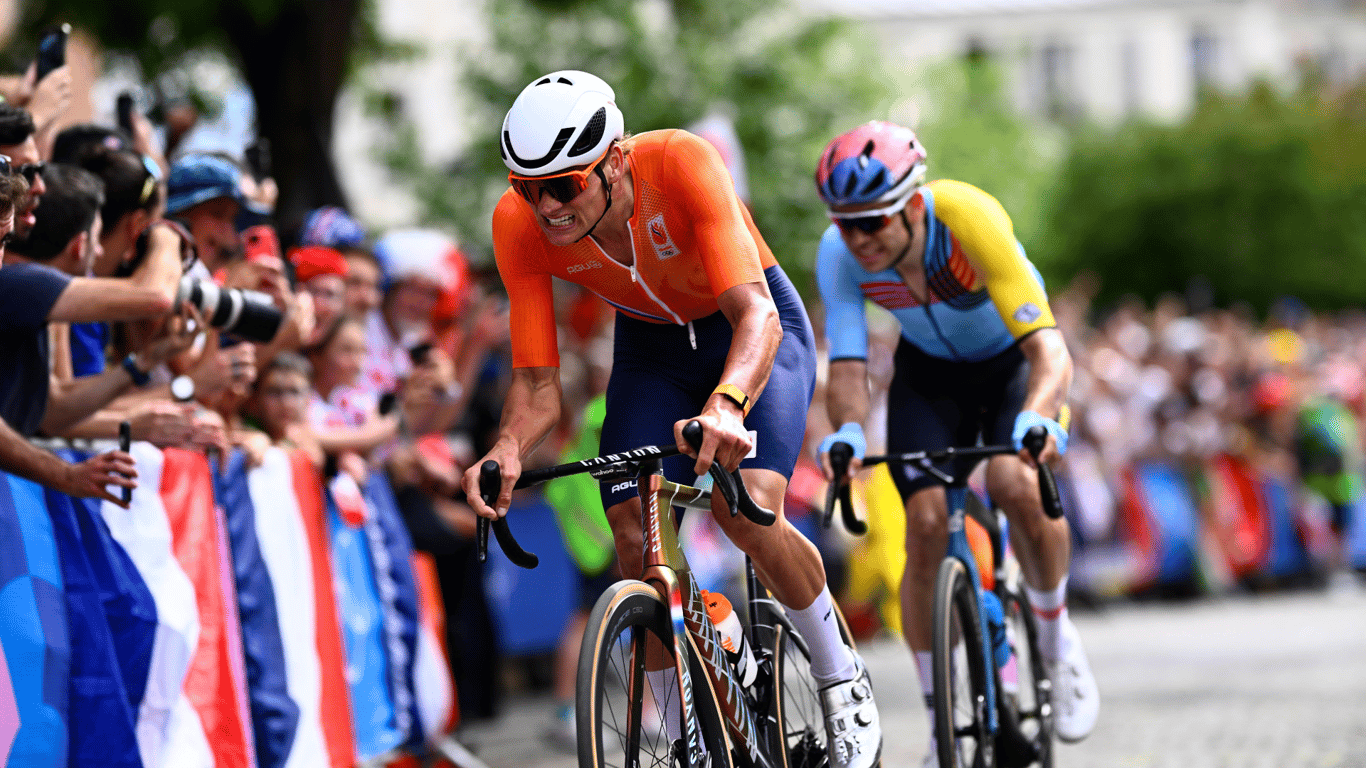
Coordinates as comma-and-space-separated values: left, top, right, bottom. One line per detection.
464, 71, 882, 768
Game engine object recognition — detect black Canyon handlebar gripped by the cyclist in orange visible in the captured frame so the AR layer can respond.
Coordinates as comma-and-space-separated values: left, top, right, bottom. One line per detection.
475, 421, 777, 568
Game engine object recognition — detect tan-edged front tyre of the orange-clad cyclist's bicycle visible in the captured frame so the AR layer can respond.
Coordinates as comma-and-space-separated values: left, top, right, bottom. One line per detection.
575, 579, 731, 768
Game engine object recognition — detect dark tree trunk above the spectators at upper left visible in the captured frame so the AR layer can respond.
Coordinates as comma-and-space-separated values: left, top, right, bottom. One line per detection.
223, 0, 361, 238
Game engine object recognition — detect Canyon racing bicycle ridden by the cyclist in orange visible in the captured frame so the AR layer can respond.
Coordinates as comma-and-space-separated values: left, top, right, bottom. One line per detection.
478, 421, 854, 768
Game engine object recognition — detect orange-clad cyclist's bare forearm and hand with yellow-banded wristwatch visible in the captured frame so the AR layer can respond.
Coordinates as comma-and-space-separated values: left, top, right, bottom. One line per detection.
673, 277, 783, 474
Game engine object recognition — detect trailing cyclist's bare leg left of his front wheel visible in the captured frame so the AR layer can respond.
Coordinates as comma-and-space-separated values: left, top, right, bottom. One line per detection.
900, 485, 948, 653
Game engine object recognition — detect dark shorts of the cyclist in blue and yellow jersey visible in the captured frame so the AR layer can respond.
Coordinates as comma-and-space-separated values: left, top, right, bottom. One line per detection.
887, 338, 1029, 502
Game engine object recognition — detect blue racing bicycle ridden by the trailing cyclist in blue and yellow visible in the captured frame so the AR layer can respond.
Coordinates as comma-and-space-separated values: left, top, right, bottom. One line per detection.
825, 426, 1063, 768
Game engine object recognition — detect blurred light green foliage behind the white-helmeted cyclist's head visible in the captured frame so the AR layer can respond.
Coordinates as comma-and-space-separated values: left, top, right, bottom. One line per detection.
388, 0, 889, 292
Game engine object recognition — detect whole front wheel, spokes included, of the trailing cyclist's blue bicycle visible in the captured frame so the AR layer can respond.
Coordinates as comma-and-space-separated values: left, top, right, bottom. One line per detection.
932, 558, 994, 768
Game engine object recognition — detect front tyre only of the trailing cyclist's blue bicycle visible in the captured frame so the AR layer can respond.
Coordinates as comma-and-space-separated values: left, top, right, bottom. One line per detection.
932, 558, 994, 768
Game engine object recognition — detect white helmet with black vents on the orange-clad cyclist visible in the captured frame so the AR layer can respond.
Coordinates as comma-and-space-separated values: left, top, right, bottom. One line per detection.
499, 70, 624, 176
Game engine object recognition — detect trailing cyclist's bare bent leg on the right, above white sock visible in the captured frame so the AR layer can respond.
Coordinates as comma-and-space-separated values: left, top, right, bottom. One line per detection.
986, 456, 1071, 590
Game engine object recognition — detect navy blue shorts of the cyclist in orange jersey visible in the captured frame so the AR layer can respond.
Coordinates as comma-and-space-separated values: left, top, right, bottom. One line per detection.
601, 266, 816, 508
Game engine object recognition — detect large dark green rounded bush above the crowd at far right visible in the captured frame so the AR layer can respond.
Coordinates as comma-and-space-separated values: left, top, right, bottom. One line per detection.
1048, 79, 1366, 309
